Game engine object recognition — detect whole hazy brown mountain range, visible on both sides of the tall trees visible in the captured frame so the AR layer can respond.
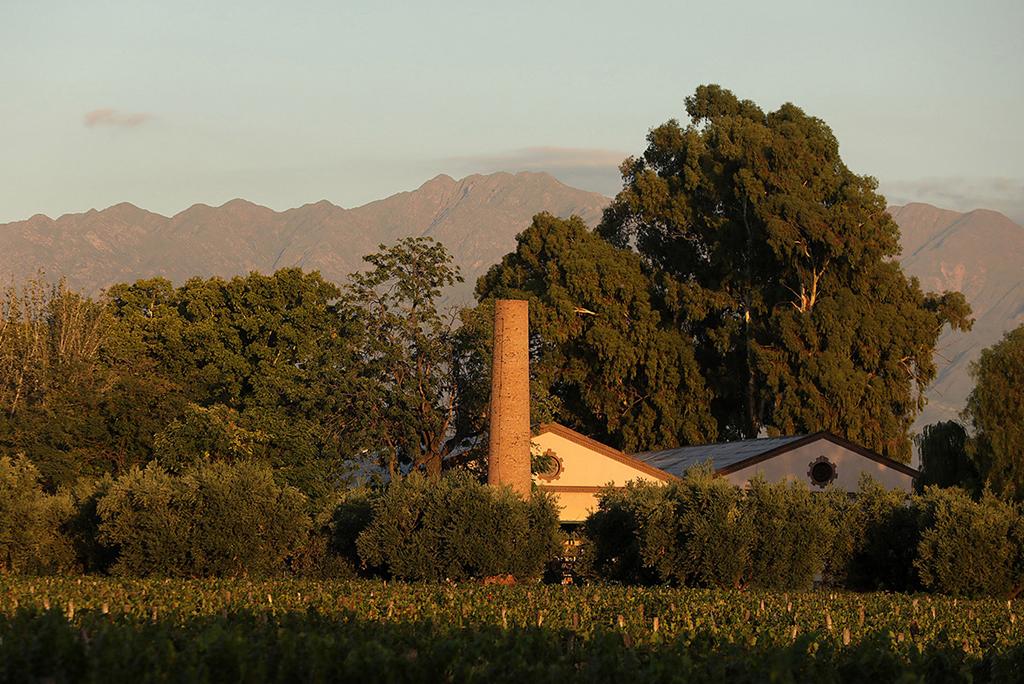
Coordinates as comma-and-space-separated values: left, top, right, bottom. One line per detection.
0, 172, 1024, 436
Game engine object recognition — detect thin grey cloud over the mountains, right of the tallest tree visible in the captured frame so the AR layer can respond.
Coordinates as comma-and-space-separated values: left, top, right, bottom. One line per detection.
881, 178, 1024, 225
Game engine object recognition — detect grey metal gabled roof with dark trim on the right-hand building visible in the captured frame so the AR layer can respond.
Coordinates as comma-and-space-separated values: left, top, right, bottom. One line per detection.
633, 430, 919, 477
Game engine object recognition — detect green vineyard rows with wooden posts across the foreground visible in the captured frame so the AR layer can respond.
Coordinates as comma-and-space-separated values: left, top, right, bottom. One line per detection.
0, 576, 1024, 684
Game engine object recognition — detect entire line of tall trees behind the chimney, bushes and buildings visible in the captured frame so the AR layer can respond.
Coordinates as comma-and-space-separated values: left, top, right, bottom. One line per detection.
0, 86, 983, 498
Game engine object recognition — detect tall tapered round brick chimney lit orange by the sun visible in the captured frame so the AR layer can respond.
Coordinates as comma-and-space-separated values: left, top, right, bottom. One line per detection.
487, 299, 531, 499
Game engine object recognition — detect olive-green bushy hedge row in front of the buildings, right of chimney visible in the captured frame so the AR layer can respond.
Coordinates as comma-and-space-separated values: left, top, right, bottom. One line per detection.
583, 471, 1024, 596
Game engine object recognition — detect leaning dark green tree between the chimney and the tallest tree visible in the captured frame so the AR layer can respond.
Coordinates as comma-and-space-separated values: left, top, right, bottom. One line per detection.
475, 213, 716, 452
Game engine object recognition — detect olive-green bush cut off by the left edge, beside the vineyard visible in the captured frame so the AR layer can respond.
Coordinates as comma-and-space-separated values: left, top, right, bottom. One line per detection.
0, 456, 75, 573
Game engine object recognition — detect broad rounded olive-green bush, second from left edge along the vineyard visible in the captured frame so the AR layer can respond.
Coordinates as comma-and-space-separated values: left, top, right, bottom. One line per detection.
96, 461, 310, 576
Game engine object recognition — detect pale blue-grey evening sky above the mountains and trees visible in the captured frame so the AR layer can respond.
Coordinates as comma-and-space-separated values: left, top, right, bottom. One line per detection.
0, 0, 1024, 223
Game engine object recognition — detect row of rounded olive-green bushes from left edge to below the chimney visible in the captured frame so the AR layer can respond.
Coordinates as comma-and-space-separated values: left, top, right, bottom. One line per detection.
0, 457, 562, 581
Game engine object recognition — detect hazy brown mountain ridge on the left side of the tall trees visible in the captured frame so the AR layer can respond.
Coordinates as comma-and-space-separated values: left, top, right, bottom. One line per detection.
0, 172, 608, 303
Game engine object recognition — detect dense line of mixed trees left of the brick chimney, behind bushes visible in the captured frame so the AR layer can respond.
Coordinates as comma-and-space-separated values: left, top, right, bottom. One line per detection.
0, 239, 485, 499
